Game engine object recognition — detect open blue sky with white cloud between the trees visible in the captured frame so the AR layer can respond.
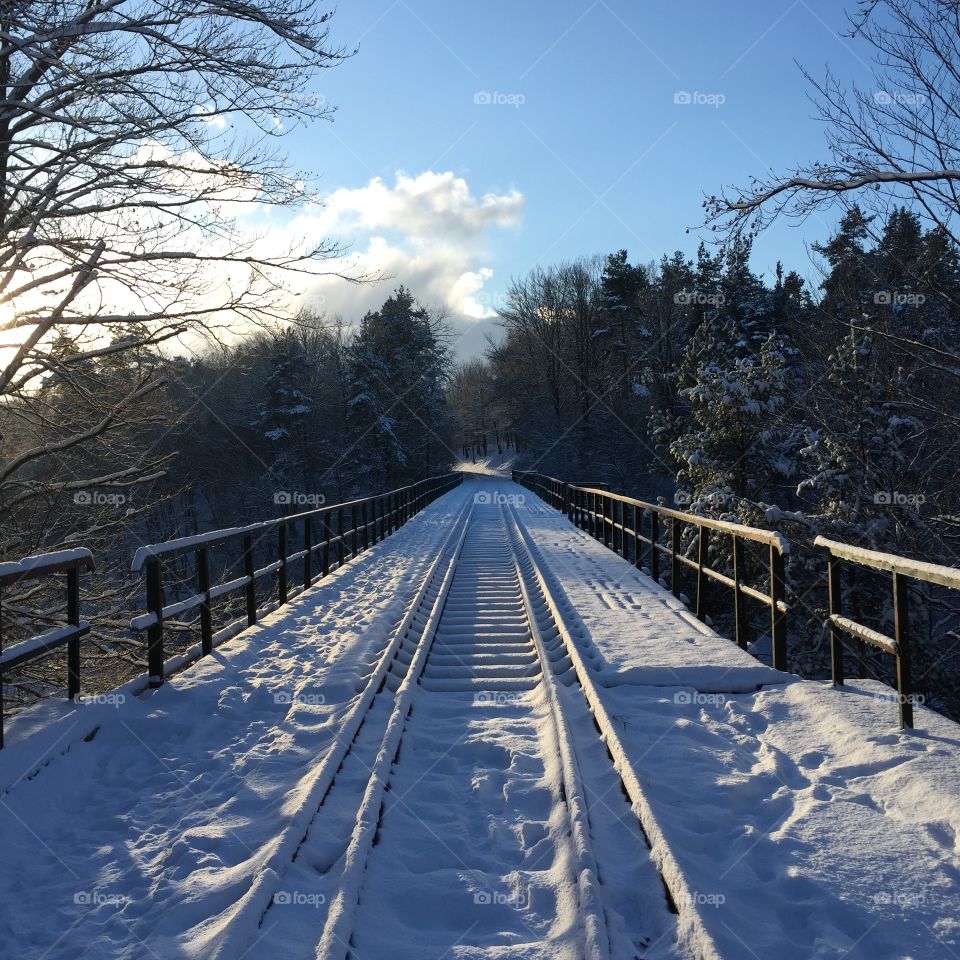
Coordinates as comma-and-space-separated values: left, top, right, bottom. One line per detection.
278, 0, 870, 354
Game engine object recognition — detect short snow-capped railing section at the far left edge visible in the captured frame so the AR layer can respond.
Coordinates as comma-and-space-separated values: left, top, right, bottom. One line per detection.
0, 547, 94, 747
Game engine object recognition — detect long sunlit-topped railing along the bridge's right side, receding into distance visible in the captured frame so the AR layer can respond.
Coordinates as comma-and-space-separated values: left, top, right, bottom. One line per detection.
513, 471, 790, 670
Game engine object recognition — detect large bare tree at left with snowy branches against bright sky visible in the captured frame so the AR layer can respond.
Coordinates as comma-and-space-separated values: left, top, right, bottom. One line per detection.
0, 0, 354, 532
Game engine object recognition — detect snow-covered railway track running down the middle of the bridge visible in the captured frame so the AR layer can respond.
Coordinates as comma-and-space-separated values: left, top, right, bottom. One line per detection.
244, 505, 676, 960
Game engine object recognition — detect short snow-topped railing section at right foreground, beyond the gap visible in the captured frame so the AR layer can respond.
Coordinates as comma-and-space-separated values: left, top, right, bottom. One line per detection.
814, 537, 960, 727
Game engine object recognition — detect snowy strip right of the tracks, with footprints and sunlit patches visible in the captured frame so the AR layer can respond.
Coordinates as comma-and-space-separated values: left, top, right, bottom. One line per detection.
501, 483, 960, 960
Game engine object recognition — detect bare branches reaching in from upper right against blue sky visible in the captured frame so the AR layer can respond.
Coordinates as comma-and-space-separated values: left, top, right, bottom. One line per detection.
705, 0, 960, 242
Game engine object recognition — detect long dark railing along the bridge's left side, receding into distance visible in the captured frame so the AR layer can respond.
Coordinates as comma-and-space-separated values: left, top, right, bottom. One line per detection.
130, 473, 463, 686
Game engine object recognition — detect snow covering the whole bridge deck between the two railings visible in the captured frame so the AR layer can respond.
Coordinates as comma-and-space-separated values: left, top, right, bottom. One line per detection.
0, 476, 960, 960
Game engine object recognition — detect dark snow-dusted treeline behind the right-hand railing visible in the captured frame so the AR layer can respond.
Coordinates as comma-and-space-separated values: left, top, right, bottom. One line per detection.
461, 209, 960, 714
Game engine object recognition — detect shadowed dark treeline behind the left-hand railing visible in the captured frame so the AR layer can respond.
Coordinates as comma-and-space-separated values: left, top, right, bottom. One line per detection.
0, 288, 453, 702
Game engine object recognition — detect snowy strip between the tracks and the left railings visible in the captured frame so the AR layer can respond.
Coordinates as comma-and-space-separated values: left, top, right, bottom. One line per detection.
0, 490, 476, 960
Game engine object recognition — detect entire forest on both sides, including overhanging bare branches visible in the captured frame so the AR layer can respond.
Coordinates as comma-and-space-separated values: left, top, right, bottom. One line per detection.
0, 0, 960, 716
